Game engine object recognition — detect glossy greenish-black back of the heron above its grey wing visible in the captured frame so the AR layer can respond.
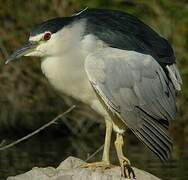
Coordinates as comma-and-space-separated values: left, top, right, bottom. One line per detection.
77, 9, 175, 67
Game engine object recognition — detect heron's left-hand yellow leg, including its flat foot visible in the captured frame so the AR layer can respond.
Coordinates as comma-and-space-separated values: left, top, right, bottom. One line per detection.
81, 119, 112, 169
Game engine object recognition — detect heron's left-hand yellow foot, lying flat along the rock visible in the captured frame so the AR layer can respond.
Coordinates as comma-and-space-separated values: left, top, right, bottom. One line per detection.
80, 161, 114, 171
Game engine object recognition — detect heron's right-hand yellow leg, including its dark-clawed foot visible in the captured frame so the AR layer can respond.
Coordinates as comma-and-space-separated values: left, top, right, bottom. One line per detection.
115, 133, 135, 178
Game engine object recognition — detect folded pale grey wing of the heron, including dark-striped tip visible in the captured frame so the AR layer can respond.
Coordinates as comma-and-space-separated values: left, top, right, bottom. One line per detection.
85, 48, 176, 160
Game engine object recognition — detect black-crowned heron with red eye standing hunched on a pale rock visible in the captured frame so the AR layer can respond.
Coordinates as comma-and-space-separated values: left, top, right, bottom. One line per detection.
6, 8, 182, 178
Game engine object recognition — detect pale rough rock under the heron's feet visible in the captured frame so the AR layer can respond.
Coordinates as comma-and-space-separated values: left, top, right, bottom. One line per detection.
7, 157, 160, 180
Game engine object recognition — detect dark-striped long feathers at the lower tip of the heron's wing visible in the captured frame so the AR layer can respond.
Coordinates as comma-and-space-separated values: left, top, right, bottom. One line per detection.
133, 109, 172, 161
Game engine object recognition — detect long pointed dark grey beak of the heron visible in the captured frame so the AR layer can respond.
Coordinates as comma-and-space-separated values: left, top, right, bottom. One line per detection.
5, 41, 37, 64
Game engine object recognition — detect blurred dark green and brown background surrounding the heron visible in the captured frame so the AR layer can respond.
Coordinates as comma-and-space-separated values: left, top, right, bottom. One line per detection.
0, 0, 188, 180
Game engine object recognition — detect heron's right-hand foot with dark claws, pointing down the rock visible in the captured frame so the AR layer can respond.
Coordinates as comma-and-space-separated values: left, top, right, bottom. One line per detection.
120, 157, 136, 179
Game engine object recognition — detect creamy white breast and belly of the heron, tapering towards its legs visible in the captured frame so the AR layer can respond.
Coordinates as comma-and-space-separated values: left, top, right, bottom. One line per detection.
41, 50, 107, 116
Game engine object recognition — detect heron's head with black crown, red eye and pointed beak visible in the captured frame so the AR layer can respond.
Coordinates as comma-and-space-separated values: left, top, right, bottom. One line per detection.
6, 17, 85, 64
